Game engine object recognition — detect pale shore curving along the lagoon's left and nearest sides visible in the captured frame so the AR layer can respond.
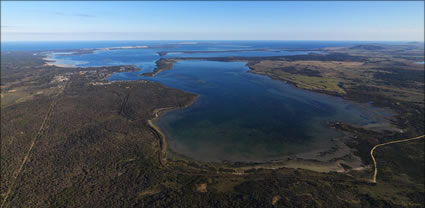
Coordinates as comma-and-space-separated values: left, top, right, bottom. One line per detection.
147, 95, 370, 175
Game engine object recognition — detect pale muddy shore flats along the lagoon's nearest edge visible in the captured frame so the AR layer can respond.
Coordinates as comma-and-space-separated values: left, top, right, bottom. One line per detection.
167, 130, 370, 174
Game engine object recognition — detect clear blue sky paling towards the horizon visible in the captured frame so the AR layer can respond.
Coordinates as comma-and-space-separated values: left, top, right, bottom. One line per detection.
1, 1, 424, 42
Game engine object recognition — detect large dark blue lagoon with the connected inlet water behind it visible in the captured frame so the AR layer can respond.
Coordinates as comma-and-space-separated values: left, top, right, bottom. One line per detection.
40, 42, 390, 161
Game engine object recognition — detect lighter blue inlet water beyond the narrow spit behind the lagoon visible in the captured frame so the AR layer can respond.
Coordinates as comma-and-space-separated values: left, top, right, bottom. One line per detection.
43, 41, 324, 74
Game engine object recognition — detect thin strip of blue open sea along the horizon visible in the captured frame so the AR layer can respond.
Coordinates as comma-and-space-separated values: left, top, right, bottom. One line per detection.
1, 40, 385, 51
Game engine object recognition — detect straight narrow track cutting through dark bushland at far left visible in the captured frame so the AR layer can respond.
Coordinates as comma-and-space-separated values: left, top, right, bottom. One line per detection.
0, 81, 69, 207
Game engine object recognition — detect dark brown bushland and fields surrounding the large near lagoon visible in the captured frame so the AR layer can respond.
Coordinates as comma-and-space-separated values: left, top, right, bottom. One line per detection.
1, 43, 424, 207
